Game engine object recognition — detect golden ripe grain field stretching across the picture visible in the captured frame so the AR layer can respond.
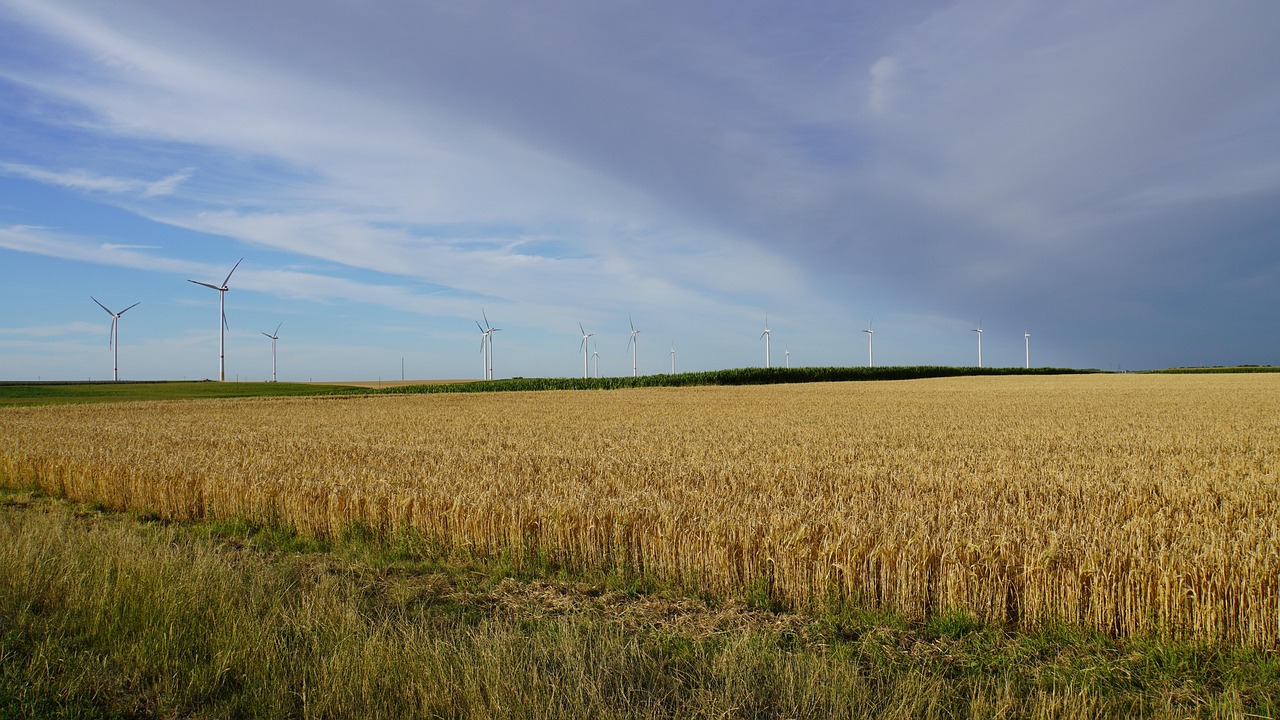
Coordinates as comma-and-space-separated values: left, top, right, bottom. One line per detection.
0, 374, 1280, 647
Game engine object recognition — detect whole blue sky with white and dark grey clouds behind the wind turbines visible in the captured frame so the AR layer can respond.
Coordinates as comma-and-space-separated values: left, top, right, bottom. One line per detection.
0, 0, 1280, 380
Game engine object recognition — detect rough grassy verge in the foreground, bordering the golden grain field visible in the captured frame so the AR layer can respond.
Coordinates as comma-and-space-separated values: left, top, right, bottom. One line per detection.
0, 491, 1280, 719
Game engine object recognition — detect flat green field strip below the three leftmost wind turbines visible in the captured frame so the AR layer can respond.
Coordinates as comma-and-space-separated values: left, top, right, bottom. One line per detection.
0, 380, 369, 407
